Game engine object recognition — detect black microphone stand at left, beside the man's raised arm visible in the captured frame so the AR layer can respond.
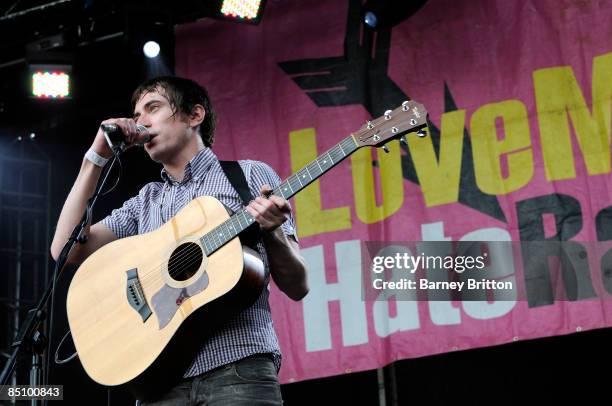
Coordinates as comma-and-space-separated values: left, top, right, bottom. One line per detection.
0, 138, 126, 406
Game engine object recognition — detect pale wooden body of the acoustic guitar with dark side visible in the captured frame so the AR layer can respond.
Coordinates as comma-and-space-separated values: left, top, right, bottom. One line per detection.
66, 197, 264, 399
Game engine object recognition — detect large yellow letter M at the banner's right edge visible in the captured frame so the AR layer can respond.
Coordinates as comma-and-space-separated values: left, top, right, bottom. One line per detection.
533, 53, 612, 180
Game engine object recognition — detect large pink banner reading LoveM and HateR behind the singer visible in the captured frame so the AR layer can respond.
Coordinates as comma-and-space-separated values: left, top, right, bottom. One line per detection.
176, 0, 612, 382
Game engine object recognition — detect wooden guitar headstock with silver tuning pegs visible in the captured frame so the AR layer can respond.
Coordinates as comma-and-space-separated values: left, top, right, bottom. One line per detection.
353, 101, 427, 149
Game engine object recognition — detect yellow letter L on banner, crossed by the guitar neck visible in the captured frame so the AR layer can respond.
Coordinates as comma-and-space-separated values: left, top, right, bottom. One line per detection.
289, 128, 351, 237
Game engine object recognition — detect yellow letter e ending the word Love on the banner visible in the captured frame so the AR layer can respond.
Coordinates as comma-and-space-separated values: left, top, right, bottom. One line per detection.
470, 100, 533, 195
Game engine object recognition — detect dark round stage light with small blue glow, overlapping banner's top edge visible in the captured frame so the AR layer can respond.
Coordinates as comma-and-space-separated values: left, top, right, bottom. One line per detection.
362, 0, 427, 29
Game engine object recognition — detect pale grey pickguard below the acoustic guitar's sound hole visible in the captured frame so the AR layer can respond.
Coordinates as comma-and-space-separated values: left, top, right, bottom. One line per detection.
151, 272, 208, 330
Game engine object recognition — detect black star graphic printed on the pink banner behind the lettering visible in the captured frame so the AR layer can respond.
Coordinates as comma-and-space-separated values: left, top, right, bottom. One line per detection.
278, 0, 506, 222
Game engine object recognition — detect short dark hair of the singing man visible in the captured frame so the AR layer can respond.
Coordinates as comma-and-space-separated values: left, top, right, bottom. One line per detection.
132, 76, 216, 147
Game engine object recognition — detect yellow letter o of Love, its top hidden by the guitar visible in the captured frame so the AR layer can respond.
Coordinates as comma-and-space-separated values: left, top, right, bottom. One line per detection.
351, 141, 404, 224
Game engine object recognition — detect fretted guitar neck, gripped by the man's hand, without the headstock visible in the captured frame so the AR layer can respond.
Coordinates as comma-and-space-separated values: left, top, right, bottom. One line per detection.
200, 135, 359, 255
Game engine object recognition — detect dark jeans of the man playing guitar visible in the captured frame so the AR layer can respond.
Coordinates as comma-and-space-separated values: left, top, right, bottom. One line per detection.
140, 354, 283, 406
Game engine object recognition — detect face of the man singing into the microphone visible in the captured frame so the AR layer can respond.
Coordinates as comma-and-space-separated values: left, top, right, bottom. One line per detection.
134, 90, 189, 163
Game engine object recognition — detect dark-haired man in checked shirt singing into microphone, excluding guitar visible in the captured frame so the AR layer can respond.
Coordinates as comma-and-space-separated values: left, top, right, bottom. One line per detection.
51, 77, 308, 405
